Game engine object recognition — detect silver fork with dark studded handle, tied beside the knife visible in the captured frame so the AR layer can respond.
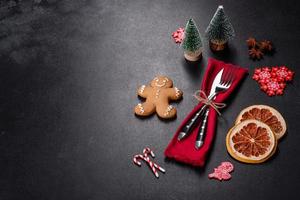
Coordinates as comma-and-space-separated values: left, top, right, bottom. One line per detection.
195, 68, 235, 149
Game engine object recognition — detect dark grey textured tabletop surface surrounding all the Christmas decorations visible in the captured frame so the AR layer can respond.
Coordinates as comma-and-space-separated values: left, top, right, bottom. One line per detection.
0, 0, 300, 200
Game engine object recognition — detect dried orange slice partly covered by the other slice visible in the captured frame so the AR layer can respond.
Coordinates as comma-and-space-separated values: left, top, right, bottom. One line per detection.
235, 105, 286, 139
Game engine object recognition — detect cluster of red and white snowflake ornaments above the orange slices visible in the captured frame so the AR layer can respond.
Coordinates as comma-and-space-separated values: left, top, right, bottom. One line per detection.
252, 66, 294, 96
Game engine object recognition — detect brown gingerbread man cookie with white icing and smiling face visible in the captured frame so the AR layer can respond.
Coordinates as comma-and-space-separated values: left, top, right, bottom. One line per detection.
134, 76, 182, 119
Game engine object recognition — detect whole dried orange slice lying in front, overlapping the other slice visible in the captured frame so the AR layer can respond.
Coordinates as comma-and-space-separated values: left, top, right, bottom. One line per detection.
226, 119, 277, 163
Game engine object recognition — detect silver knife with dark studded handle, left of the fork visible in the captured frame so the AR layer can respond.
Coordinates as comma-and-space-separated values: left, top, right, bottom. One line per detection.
177, 68, 224, 140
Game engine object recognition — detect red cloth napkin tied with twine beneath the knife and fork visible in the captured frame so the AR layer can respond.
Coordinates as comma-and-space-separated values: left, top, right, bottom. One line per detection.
165, 58, 248, 166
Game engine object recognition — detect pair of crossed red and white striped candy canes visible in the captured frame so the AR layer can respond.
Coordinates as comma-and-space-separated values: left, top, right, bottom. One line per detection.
133, 147, 166, 178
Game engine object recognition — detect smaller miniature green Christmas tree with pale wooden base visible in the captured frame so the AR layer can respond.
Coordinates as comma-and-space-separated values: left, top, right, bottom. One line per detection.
182, 19, 203, 61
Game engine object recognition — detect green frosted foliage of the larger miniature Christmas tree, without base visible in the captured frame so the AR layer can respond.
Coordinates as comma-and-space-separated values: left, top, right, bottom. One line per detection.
205, 6, 235, 46
